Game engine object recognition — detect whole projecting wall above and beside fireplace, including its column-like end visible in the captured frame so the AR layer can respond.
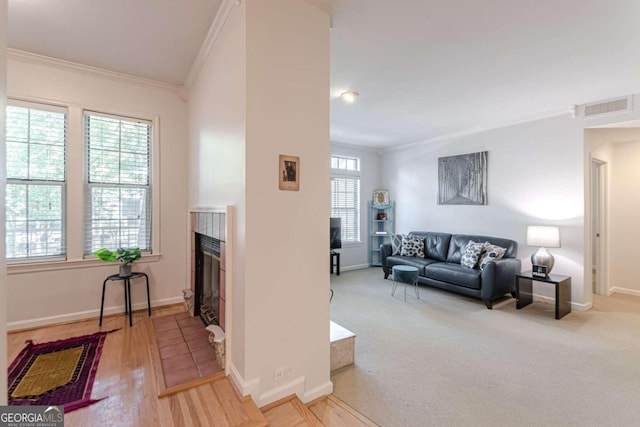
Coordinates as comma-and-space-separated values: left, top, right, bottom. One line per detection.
189, 0, 332, 406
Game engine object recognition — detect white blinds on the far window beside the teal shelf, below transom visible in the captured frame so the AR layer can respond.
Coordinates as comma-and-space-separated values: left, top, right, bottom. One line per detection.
331, 176, 360, 243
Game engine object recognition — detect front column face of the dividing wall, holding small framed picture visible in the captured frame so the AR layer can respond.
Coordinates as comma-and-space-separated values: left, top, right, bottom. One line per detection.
244, 0, 332, 406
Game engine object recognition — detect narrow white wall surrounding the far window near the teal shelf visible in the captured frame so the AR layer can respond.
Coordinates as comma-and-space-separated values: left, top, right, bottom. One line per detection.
331, 142, 380, 271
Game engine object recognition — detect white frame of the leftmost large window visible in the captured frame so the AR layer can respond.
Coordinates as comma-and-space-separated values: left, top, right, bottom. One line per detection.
4, 97, 69, 267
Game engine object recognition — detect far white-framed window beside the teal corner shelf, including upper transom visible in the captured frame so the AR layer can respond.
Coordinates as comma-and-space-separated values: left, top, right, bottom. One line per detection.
331, 156, 360, 243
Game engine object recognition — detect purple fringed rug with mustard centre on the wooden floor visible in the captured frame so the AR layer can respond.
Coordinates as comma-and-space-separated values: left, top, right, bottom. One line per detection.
8, 329, 117, 413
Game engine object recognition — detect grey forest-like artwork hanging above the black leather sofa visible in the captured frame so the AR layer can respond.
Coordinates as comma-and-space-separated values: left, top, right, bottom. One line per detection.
438, 151, 488, 205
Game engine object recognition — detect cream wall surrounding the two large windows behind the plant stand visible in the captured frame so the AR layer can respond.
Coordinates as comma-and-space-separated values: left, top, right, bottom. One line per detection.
7, 54, 187, 328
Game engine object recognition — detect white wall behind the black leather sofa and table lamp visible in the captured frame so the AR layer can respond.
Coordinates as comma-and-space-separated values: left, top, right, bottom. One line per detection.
382, 95, 640, 309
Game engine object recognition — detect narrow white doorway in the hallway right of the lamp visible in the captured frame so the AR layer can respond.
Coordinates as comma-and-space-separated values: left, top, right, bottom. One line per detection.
591, 158, 608, 295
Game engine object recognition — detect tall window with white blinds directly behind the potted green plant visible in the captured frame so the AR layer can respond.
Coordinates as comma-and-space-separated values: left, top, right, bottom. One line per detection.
84, 112, 152, 255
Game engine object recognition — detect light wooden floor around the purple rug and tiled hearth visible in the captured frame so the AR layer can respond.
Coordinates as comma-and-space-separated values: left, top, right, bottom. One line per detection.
7, 305, 375, 427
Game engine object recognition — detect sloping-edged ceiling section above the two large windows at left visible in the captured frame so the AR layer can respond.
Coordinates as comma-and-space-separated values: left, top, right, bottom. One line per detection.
8, 0, 222, 84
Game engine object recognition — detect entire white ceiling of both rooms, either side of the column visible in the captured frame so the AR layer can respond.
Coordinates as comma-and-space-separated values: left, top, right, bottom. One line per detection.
9, 0, 640, 148
